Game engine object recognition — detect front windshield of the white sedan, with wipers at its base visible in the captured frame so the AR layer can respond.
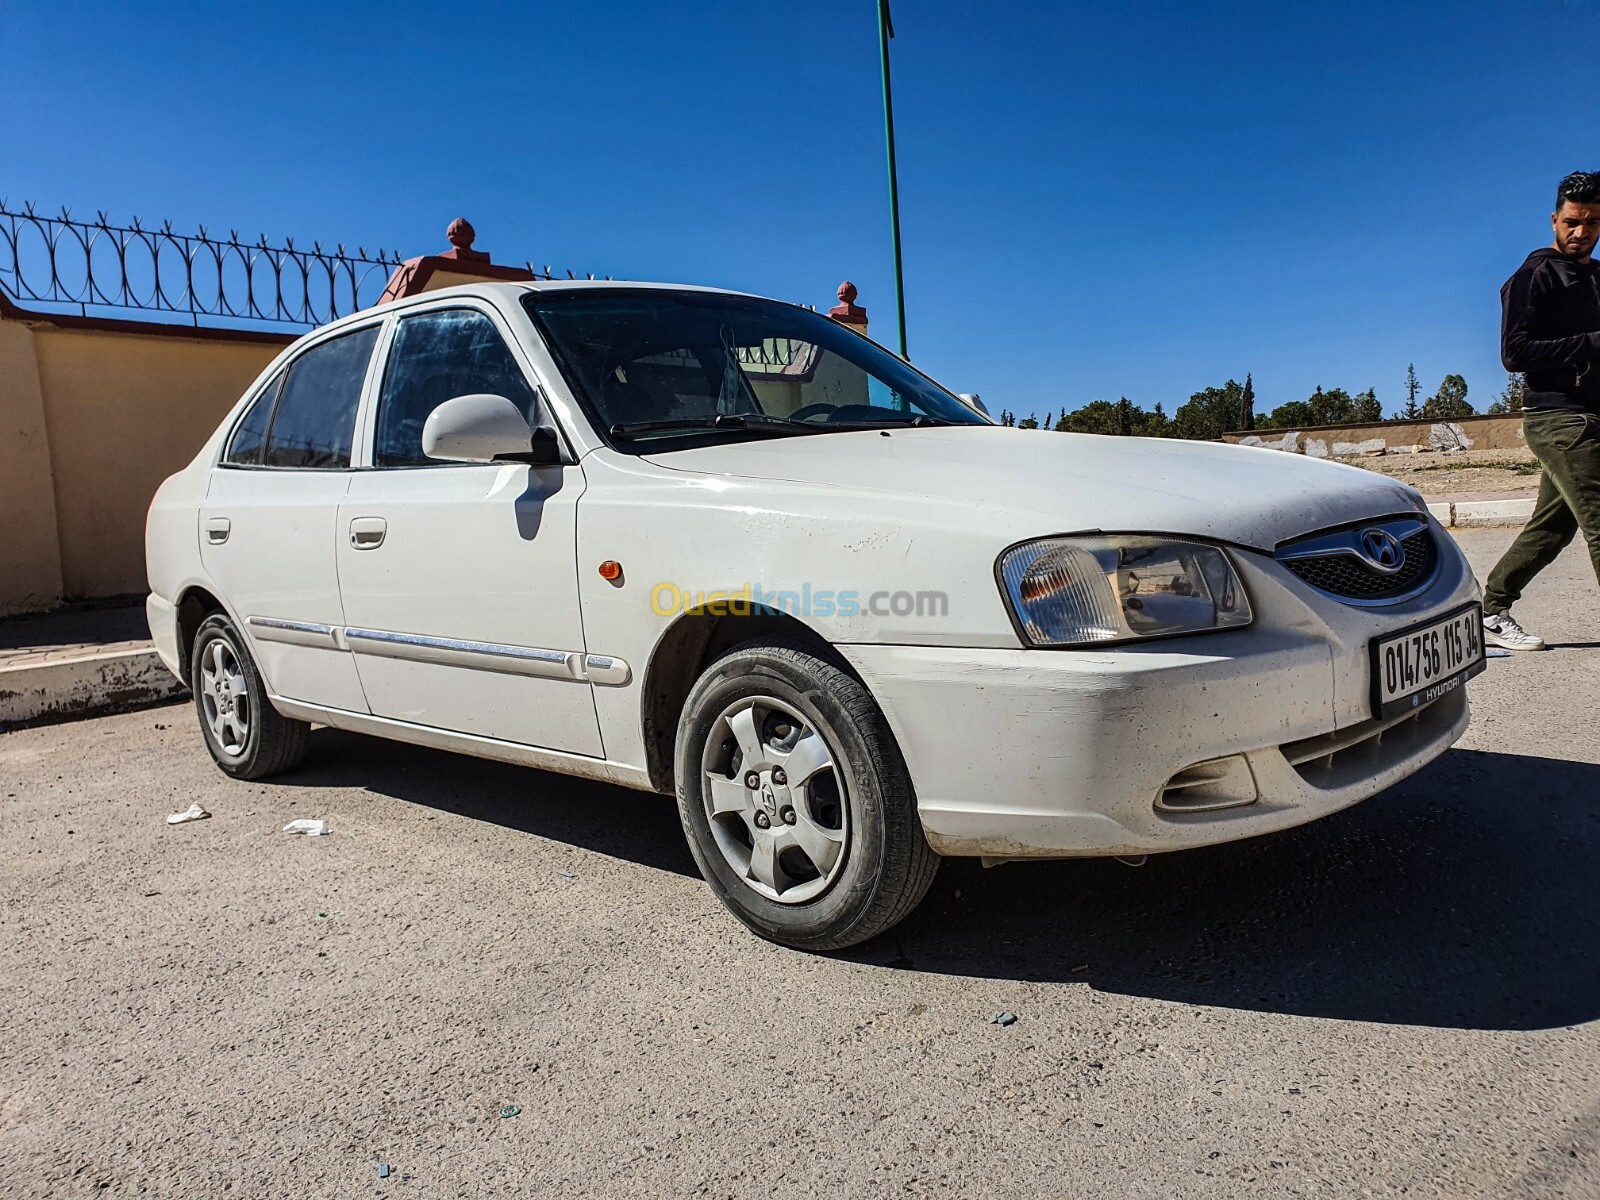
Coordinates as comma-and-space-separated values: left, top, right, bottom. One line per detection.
523, 288, 990, 453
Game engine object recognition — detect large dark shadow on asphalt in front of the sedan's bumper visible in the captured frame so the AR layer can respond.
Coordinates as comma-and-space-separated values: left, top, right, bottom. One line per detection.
850, 750, 1600, 1030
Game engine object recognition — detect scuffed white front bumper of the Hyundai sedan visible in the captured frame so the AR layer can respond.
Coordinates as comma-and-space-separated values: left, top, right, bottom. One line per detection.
838, 526, 1478, 858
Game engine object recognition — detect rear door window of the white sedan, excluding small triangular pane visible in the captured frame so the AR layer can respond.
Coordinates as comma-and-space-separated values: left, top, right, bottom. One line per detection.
261, 325, 387, 470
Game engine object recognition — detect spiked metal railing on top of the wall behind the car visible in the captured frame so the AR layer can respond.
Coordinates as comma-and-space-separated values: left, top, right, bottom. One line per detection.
0, 200, 594, 328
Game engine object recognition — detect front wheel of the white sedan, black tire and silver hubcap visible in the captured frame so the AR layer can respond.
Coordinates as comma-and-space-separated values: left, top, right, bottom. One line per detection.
675, 640, 939, 950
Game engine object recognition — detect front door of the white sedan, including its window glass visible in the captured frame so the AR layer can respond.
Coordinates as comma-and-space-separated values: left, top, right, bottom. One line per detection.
338, 307, 602, 757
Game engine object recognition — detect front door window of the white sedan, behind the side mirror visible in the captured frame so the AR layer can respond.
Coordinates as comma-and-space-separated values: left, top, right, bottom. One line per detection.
373, 309, 534, 467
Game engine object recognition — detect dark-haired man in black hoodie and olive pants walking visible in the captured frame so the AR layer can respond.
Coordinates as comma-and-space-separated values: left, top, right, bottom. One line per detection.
1483, 171, 1600, 650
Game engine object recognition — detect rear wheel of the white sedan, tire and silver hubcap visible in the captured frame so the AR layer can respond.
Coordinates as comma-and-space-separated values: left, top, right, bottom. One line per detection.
189, 613, 310, 779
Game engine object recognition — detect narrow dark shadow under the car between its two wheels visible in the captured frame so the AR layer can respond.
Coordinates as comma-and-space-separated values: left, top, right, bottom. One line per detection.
283, 730, 699, 878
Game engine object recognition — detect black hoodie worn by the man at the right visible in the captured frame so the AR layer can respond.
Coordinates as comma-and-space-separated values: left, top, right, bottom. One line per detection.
1501, 246, 1600, 416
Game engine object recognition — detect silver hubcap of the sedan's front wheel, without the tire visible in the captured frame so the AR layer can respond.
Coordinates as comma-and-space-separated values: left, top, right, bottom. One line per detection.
701, 696, 850, 904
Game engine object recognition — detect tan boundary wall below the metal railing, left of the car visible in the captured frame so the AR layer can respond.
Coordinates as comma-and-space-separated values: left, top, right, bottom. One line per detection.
0, 309, 288, 613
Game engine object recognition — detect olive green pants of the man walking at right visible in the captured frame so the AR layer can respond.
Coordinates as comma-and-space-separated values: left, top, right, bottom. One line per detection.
1483, 408, 1600, 613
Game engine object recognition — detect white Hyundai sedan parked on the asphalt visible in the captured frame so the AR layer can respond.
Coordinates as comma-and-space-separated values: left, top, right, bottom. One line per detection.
147, 283, 1483, 949
